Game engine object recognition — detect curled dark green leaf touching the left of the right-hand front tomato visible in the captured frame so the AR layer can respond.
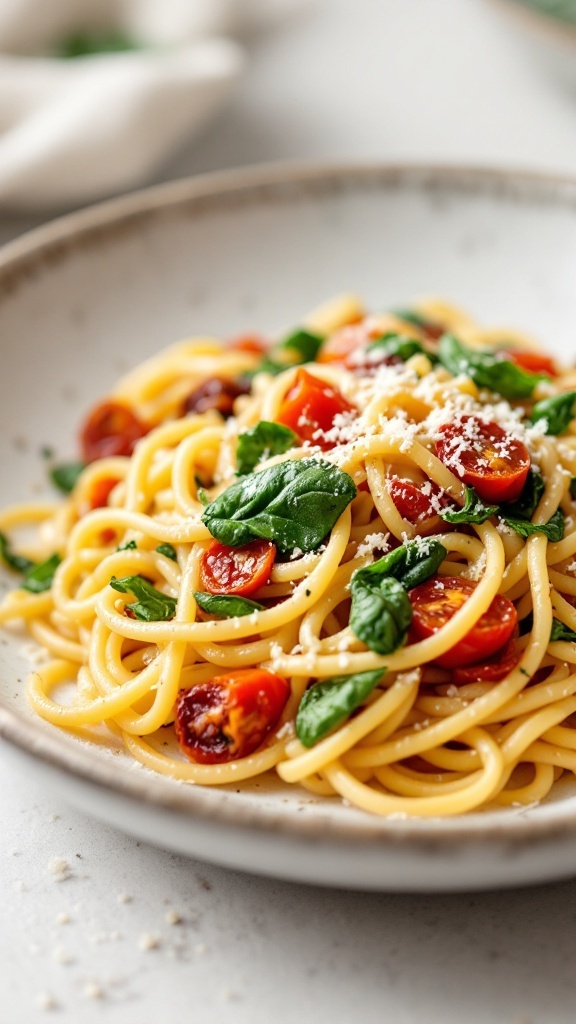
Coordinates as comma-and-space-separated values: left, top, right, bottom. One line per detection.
349, 540, 447, 654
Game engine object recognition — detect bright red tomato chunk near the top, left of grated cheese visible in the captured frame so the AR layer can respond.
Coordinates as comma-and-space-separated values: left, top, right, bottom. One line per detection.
277, 370, 357, 452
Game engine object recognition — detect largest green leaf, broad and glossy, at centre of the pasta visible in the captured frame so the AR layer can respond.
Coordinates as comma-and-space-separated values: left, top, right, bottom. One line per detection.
202, 459, 356, 552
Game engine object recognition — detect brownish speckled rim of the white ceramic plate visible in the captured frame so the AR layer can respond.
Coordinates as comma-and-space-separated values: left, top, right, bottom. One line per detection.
0, 163, 576, 853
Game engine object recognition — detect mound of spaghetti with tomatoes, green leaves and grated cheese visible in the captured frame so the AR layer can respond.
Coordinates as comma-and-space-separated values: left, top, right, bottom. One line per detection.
0, 296, 576, 816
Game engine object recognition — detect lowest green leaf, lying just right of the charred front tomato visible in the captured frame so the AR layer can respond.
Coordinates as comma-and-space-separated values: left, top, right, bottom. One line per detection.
296, 669, 385, 746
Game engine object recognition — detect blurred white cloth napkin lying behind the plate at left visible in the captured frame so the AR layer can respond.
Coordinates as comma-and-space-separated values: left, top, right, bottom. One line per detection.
0, 0, 305, 208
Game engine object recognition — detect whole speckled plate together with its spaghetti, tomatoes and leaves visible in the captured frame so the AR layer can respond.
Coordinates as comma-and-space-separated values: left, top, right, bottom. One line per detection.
0, 167, 576, 890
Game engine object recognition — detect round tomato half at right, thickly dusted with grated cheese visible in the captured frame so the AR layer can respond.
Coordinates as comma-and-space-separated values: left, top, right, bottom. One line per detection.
436, 416, 530, 502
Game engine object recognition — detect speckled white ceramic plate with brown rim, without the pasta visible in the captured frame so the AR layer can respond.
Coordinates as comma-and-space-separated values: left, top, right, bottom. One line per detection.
0, 161, 576, 891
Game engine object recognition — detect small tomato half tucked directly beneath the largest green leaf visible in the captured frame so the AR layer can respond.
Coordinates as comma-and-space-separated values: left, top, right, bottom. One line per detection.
200, 541, 276, 597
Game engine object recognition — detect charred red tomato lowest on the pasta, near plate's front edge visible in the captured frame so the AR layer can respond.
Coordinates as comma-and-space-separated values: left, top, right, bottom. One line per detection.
175, 669, 290, 765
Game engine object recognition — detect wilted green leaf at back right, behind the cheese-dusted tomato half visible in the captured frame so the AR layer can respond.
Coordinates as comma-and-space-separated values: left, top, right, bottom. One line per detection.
438, 334, 546, 398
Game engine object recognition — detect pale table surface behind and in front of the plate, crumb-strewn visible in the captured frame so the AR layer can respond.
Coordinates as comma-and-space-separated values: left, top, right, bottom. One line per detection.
0, 0, 576, 1024
